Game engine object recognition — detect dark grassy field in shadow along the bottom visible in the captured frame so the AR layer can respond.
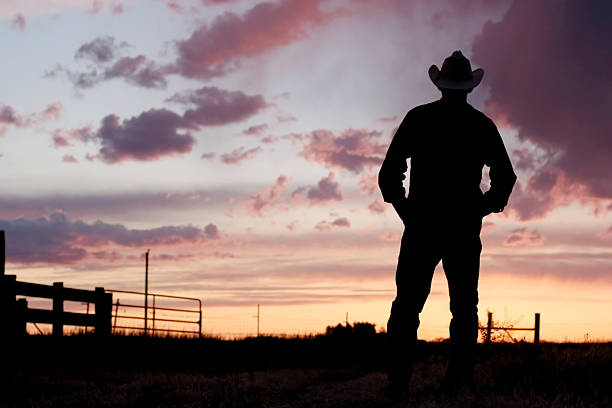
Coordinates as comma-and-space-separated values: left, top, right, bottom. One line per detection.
0, 334, 612, 408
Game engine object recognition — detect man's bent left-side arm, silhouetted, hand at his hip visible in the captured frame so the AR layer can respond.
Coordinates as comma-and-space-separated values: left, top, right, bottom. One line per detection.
378, 112, 410, 220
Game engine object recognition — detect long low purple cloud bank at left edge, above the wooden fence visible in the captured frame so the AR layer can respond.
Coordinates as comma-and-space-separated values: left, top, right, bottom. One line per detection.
0, 212, 219, 264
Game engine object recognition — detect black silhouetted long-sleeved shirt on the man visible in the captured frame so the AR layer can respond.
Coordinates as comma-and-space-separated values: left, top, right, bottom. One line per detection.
378, 98, 516, 217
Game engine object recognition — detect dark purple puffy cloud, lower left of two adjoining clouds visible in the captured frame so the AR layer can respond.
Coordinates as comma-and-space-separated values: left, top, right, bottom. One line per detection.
93, 109, 195, 164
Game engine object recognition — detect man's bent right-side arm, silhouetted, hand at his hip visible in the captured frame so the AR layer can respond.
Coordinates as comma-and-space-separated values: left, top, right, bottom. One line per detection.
483, 119, 516, 215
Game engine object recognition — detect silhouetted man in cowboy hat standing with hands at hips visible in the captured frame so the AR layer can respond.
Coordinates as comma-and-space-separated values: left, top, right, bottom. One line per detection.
378, 51, 516, 394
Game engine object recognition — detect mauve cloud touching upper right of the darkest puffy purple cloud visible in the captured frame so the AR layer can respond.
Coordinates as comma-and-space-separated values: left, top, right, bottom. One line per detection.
167, 86, 268, 126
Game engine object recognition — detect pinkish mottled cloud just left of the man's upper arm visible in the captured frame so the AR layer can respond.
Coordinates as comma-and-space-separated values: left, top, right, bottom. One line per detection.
299, 129, 387, 173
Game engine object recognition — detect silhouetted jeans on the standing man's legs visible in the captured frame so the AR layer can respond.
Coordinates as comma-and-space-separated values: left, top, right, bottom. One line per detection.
387, 217, 482, 382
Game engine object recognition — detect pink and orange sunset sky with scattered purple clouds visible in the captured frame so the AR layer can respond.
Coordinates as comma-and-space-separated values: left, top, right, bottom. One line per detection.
0, 0, 612, 341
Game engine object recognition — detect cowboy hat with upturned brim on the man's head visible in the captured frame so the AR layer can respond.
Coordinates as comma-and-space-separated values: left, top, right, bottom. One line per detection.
428, 51, 484, 89
